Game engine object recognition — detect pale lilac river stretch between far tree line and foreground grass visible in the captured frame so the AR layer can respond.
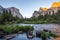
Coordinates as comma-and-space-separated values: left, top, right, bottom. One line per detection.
19, 24, 60, 32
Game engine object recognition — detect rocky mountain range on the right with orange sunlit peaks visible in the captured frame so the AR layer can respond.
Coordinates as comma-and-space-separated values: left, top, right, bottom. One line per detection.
32, 2, 60, 17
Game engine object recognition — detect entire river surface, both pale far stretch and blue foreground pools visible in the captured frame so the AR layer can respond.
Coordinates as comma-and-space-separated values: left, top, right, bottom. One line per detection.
0, 24, 60, 40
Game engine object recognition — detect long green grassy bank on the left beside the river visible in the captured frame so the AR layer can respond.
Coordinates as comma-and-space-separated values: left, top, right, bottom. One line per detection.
0, 25, 34, 34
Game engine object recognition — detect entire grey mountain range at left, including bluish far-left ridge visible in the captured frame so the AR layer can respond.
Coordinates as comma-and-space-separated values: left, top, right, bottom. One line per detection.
0, 5, 23, 18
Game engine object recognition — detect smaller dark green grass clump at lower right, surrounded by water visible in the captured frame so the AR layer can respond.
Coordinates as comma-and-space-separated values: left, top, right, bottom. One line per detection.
35, 31, 58, 38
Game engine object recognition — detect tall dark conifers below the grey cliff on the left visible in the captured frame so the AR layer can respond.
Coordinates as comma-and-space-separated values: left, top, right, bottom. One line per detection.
0, 10, 21, 24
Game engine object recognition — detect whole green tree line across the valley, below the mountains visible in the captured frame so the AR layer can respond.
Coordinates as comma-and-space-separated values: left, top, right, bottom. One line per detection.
0, 10, 60, 24
